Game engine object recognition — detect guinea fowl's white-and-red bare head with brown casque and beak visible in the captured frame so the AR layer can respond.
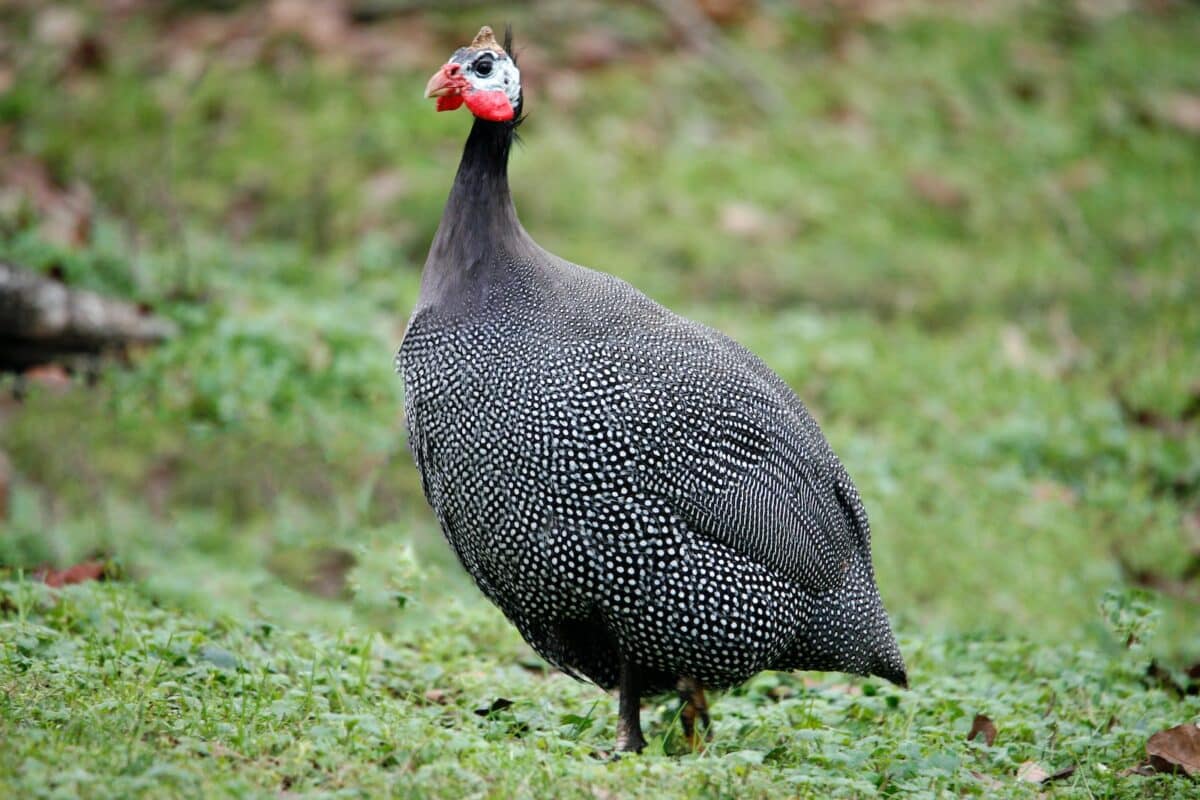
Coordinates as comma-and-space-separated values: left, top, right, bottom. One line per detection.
425, 25, 521, 122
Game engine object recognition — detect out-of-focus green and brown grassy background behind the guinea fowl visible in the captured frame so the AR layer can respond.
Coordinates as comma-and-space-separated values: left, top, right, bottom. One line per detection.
0, 0, 1200, 664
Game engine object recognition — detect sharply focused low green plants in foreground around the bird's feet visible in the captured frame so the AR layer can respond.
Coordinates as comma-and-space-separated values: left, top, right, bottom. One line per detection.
0, 582, 1200, 798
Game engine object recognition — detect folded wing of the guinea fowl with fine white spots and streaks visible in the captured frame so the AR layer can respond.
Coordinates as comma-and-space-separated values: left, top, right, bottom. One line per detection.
612, 316, 870, 591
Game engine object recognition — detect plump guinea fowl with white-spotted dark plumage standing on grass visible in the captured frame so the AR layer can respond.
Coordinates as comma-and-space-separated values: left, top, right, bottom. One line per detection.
396, 28, 906, 751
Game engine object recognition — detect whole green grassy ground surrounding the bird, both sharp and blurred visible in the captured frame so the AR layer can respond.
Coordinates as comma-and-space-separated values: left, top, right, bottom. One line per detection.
0, 2, 1200, 798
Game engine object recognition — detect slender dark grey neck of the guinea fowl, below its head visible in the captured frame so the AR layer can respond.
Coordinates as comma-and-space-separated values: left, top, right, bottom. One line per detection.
421, 118, 534, 305
